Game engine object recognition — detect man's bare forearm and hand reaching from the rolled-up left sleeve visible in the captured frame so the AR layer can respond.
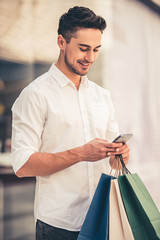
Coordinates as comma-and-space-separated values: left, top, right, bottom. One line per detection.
16, 139, 121, 177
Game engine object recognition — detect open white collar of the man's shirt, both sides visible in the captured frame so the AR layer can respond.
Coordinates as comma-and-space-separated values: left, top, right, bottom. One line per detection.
49, 64, 88, 88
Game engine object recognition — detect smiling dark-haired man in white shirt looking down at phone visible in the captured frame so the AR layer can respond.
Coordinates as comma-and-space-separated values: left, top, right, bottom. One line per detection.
11, 7, 129, 240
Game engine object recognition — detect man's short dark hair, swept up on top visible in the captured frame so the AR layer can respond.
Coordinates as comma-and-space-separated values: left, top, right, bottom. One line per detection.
58, 6, 106, 43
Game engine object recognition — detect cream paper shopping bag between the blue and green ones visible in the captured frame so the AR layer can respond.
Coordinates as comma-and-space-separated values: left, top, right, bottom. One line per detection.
109, 179, 134, 240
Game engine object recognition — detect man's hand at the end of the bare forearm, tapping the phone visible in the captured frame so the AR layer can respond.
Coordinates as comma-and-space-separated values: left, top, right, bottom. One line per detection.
78, 138, 122, 162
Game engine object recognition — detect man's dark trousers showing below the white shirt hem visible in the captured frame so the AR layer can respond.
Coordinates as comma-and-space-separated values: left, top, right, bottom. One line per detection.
36, 220, 79, 240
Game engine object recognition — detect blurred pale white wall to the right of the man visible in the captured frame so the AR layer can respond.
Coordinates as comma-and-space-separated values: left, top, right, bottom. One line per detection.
103, 0, 160, 208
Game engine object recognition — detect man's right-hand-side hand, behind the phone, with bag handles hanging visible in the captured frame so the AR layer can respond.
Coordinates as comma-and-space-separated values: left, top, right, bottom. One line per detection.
109, 144, 130, 170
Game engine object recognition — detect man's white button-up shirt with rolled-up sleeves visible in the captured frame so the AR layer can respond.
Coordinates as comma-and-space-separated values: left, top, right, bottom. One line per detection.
11, 64, 118, 231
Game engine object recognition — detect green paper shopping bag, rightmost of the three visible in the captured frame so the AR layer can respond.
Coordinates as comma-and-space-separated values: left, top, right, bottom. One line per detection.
118, 174, 160, 240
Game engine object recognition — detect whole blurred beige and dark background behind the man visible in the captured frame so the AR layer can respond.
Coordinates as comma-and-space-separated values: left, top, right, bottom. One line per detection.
0, 0, 160, 240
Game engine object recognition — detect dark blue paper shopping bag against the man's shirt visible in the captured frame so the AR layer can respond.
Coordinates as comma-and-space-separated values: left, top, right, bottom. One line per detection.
78, 173, 113, 240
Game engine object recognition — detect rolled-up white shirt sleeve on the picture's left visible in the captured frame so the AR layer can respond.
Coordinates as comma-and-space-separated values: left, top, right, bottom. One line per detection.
11, 88, 46, 173
